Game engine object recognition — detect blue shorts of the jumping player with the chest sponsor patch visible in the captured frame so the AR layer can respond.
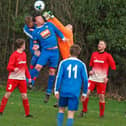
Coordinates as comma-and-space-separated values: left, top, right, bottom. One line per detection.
37, 49, 59, 68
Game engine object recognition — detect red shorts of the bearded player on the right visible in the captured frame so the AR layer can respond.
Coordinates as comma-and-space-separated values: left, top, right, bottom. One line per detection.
88, 80, 107, 94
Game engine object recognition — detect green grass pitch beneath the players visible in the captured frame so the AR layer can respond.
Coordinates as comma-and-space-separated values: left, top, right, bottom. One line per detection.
0, 87, 126, 126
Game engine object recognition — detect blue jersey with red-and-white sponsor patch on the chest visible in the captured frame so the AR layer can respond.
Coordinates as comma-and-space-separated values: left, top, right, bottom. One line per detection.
33, 22, 64, 49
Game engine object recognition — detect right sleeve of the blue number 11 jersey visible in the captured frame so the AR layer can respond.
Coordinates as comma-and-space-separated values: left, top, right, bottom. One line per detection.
81, 64, 88, 96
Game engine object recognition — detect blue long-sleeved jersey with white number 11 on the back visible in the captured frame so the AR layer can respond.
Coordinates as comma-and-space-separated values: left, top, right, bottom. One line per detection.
55, 57, 88, 97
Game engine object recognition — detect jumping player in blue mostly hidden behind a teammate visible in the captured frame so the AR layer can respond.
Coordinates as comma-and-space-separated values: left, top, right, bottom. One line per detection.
23, 16, 40, 69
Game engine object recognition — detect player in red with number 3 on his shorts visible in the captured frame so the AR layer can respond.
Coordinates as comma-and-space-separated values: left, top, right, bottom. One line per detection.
0, 39, 32, 117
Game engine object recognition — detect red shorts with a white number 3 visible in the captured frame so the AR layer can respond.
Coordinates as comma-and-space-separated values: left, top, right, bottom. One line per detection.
6, 79, 27, 93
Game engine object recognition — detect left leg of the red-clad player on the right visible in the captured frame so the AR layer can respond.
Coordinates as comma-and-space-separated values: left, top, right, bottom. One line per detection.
79, 80, 95, 117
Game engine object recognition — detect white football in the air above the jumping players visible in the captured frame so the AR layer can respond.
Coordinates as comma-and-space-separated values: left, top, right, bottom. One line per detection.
34, 0, 45, 11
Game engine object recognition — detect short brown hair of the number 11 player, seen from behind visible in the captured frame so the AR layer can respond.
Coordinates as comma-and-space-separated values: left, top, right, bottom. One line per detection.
70, 44, 81, 57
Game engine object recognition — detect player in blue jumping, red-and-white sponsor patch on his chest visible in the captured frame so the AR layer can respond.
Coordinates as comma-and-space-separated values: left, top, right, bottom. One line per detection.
30, 16, 67, 103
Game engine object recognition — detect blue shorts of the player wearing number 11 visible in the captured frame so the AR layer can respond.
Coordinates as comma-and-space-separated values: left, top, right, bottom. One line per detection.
59, 96, 79, 111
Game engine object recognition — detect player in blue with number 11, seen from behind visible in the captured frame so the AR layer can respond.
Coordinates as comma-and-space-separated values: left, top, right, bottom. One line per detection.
54, 45, 88, 126
